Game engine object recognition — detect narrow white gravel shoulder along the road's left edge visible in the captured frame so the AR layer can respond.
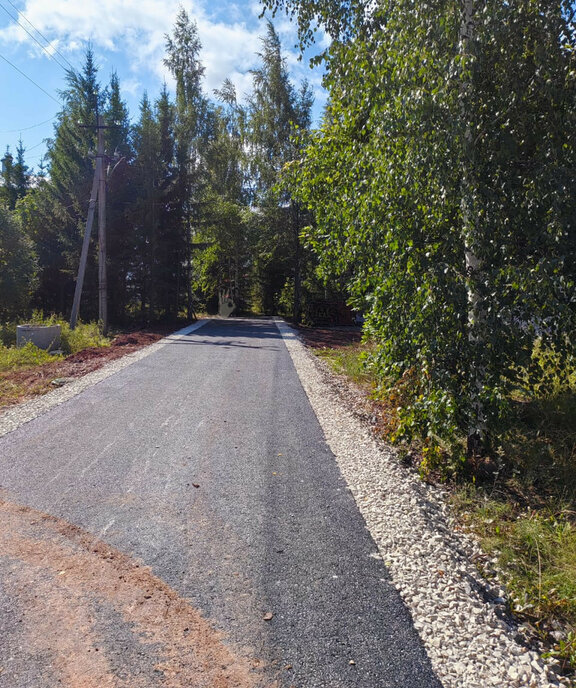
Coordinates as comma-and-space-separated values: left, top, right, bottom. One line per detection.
0, 319, 208, 437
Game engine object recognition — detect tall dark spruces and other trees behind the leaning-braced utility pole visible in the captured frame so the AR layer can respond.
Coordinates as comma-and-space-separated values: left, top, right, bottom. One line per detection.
0, 10, 312, 323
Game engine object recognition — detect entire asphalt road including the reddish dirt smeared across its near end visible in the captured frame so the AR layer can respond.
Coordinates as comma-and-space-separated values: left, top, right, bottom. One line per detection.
0, 320, 440, 688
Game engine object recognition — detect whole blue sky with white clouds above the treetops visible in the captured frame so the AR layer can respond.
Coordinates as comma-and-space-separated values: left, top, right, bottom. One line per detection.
0, 0, 325, 167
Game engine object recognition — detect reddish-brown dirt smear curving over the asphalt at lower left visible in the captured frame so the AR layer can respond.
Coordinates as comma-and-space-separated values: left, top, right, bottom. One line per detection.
0, 501, 255, 688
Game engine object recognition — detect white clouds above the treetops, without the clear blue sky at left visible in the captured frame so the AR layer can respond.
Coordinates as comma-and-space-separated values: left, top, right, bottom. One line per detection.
0, 0, 326, 117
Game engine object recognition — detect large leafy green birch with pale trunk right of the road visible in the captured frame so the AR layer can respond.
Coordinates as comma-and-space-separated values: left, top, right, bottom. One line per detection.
265, 0, 576, 456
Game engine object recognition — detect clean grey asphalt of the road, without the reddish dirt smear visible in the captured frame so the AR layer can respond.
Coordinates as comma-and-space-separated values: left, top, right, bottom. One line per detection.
0, 320, 440, 688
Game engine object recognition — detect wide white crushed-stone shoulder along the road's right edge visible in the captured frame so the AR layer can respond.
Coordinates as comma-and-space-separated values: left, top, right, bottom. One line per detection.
276, 320, 570, 688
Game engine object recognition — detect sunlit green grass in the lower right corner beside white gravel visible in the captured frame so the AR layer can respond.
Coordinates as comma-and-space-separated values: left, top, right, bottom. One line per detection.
452, 485, 576, 673
